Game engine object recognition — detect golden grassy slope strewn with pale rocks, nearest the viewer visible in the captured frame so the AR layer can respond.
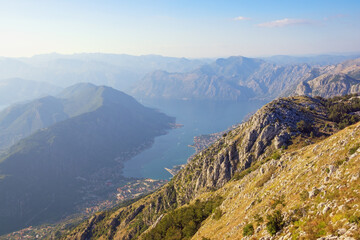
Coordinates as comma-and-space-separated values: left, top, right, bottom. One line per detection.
192, 119, 360, 239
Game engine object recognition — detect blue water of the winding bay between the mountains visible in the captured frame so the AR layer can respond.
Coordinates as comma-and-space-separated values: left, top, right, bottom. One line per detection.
124, 100, 265, 179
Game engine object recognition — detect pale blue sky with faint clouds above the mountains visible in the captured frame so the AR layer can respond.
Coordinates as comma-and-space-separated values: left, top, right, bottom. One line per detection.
0, 0, 360, 58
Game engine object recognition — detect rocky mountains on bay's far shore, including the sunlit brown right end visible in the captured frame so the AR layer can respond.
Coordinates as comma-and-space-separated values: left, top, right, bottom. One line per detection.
133, 57, 360, 101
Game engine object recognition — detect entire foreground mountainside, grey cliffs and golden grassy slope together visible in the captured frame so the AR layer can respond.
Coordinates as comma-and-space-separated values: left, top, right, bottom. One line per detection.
61, 95, 360, 240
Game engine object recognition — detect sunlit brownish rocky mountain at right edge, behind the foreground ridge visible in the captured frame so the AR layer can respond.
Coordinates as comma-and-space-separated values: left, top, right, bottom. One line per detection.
295, 58, 360, 97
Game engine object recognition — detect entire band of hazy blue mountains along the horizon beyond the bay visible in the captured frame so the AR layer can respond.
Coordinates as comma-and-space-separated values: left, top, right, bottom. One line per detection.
0, 53, 359, 107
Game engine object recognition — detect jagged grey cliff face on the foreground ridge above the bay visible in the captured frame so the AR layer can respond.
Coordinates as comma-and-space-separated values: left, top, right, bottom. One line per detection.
175, 95, 325, 204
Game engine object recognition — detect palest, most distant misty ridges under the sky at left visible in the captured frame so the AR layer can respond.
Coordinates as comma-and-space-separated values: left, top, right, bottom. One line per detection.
0, 53, 210, 94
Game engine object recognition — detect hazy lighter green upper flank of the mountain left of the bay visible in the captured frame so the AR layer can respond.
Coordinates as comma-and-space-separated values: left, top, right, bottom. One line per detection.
0, 83, 130, 149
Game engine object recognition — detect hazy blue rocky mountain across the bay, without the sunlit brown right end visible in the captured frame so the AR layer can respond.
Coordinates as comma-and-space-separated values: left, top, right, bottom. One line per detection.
133, 57, 311, 100
